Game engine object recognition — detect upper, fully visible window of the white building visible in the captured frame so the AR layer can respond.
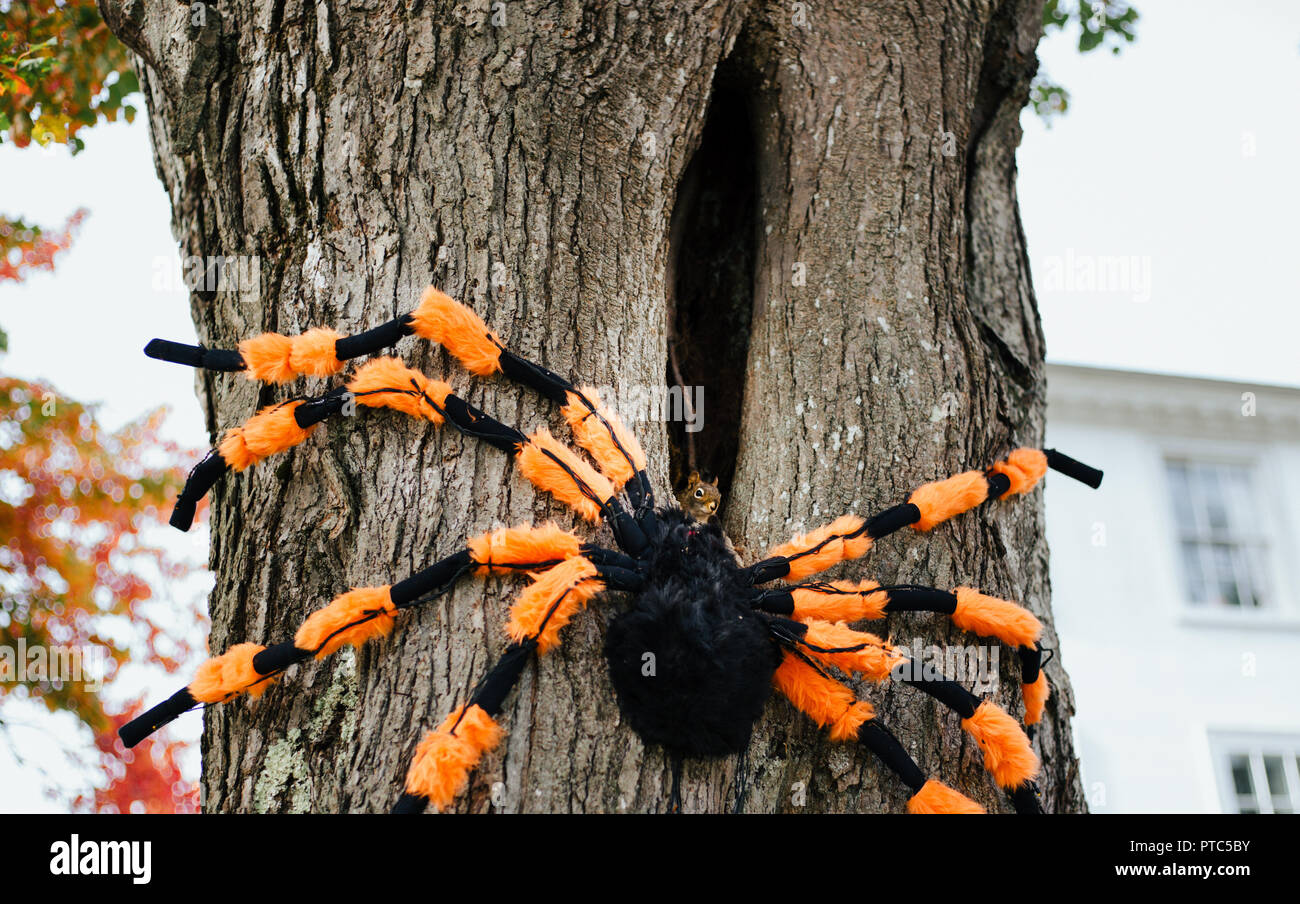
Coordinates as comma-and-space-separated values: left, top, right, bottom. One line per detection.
1166, 459, 1268, 610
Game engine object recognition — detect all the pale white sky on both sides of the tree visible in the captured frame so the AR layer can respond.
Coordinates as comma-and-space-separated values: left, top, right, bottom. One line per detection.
0, 0, 1300, 810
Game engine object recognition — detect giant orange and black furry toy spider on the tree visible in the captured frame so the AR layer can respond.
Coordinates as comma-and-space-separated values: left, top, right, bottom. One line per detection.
121, 289, 1101, 813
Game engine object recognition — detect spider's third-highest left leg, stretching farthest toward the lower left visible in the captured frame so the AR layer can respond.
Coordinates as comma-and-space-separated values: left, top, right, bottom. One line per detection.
118, 523, 637, 748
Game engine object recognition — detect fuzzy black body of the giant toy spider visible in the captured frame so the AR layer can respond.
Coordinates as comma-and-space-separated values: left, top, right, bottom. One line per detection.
605, 509, 781, 757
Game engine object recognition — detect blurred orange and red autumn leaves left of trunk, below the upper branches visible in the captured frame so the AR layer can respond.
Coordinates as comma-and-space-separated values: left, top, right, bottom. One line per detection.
0, 376, 202, 810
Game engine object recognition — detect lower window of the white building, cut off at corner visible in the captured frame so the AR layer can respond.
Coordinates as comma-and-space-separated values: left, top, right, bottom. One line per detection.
1214, 735, 1300, 813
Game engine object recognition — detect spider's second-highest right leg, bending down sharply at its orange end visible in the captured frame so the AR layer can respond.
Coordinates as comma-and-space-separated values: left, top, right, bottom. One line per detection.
753, 580, 1050, 726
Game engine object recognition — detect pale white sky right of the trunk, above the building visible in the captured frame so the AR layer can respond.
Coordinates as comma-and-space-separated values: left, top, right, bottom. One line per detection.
1017, 0, 1300, 385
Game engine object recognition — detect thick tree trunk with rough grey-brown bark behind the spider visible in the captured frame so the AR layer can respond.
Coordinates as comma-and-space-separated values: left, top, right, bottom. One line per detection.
100, 0, 1083, 812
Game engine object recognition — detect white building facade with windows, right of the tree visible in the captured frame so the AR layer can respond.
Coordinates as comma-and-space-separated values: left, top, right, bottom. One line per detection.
1045, 364, 1300, 813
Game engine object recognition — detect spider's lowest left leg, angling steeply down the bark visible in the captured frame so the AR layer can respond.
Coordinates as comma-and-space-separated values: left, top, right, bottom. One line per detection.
393, 557, 640, 813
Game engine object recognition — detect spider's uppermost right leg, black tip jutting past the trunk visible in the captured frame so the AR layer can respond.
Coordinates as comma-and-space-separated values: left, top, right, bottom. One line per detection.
745, 449, 1101, 584
